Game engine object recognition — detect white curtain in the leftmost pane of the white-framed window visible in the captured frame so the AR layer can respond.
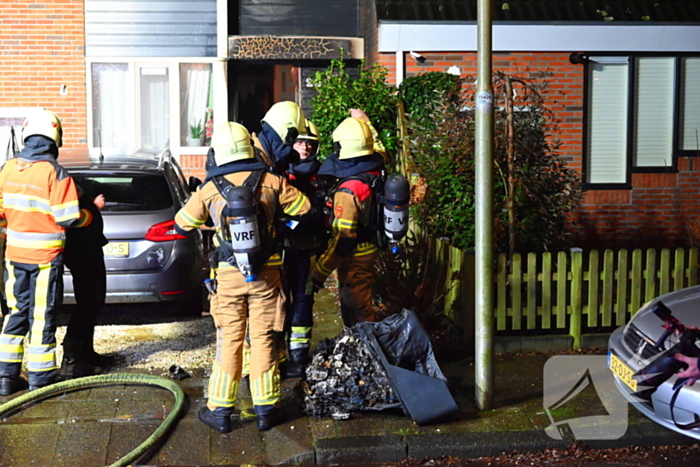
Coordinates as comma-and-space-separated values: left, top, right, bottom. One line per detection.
92, 63, 132, 154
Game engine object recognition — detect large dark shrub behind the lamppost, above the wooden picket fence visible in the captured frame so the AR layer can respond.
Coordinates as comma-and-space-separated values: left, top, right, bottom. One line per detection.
400, 73, 581, 252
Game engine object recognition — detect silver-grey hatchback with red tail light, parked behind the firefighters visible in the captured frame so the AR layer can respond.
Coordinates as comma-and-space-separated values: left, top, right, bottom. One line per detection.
59, 151, 205, 313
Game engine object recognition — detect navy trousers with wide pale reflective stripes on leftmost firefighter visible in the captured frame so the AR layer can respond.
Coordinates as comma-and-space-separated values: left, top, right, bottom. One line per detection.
0, 255, 63, 386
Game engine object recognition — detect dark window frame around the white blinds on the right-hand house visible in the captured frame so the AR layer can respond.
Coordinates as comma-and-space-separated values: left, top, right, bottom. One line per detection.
584, 53, 698, 189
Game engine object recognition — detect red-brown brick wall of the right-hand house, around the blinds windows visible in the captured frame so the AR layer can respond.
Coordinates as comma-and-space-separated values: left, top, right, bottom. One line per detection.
377, 51, 700, 248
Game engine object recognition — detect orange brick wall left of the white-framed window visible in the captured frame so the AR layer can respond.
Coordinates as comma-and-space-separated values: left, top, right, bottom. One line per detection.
0, 0, 87, 149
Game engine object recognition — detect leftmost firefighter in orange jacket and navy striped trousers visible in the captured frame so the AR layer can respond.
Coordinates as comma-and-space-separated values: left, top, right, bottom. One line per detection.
0, 110, 92, 396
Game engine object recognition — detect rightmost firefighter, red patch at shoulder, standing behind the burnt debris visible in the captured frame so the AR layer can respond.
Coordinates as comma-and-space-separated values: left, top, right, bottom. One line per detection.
312, 111, 384, 326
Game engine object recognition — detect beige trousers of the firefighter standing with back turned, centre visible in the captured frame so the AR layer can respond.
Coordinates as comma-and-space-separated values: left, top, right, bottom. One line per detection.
207, 268, 284, 410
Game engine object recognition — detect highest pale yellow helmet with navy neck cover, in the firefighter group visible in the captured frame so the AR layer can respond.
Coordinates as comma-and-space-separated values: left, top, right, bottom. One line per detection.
253, 101, 306, 174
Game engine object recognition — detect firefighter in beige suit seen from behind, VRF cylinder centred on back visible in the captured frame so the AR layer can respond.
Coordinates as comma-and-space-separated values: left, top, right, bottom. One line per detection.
175, 122, 311, 433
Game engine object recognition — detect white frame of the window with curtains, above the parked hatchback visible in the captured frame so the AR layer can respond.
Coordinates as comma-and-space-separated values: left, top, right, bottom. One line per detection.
85, 57, 228, 162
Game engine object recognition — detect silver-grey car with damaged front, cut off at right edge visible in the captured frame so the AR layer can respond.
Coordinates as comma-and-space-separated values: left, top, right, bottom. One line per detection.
608, 286, 700, 439
